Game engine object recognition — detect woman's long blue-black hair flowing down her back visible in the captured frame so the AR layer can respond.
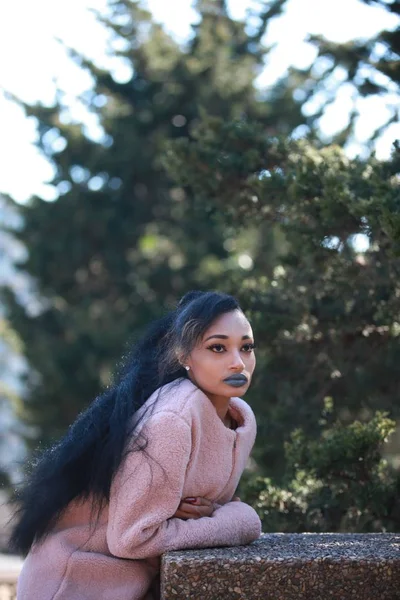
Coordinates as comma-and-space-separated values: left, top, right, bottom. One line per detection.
10, 291, 240, 554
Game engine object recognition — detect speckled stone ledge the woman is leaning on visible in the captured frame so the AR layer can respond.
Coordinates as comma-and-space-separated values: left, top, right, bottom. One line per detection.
161, 533, 400, 600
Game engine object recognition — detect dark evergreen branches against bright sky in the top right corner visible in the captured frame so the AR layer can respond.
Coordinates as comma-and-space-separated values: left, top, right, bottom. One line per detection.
289, 0, 400, 150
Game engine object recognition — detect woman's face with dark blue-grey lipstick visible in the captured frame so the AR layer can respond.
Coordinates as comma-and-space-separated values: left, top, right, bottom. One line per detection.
185, 310, 256, 398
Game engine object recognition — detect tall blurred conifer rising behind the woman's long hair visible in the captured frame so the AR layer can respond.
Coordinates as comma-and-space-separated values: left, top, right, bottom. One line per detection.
5, 0, 303, 445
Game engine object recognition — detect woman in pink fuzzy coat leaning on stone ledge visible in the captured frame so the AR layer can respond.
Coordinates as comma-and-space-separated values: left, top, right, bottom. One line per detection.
11, 292, 261, 600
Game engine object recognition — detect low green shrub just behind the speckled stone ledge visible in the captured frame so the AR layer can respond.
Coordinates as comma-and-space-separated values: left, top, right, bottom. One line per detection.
240, 412, 400, 533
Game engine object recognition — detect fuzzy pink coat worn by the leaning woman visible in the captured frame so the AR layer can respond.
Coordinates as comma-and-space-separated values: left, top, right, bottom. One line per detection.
17, 378, 261, 600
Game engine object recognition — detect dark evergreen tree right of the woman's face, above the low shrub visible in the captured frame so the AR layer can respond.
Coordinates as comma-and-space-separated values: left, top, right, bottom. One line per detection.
165, 118, 400, 481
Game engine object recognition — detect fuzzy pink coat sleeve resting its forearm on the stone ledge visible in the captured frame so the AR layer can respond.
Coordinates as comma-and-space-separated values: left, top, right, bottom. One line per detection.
107, 411, 261, 559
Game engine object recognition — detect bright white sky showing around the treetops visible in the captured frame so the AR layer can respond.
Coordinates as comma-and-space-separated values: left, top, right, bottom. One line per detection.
0, 0, 400, 202
